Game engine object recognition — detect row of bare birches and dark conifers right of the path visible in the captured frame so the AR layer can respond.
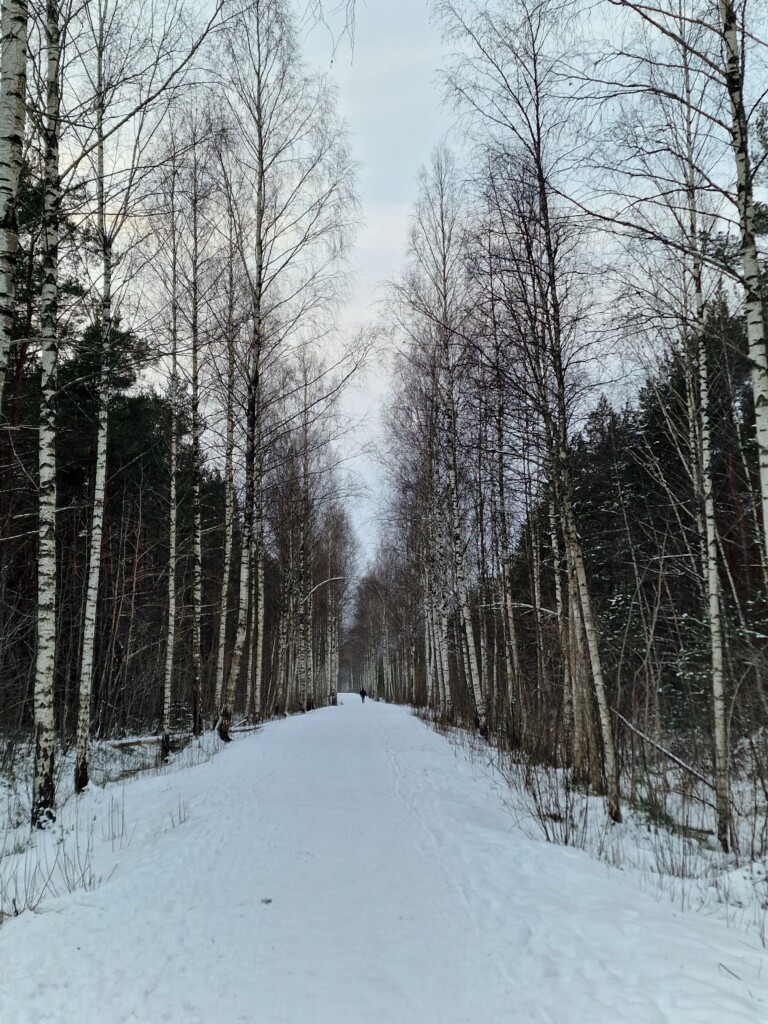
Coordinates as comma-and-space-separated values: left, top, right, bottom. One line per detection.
344, 0, 768, 855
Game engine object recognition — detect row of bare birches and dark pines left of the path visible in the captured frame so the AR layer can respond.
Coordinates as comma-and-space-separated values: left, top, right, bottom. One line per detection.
0, 0, 365, 825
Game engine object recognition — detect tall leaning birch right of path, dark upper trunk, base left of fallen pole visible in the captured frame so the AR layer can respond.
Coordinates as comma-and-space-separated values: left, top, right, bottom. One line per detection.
440, 2, 621, 821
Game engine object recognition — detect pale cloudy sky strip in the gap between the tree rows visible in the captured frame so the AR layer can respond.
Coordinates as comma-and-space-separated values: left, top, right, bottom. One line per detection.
306, 0, 453, 555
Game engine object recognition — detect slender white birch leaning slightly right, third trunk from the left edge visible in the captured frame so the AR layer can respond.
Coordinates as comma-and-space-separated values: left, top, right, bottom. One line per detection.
73, 0, 241, 792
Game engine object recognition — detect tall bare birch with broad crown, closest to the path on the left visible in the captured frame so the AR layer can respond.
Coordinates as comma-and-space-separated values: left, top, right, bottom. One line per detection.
219, 0, 354, 737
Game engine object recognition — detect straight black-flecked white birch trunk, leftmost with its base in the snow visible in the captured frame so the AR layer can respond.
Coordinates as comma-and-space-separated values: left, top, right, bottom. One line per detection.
31, 0, 60, 828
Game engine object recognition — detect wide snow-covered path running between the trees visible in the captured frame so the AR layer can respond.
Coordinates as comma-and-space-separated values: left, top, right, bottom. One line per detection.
0, 695, 768, 1024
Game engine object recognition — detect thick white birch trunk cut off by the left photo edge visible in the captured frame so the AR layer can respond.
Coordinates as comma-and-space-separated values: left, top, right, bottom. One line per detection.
0, 0, 27, 407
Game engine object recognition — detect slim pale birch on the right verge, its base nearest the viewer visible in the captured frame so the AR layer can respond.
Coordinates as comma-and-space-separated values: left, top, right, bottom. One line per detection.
593, 5, 733, 850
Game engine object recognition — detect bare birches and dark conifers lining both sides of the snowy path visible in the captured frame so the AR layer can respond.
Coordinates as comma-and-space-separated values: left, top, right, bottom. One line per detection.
0, 0, 768, 872
